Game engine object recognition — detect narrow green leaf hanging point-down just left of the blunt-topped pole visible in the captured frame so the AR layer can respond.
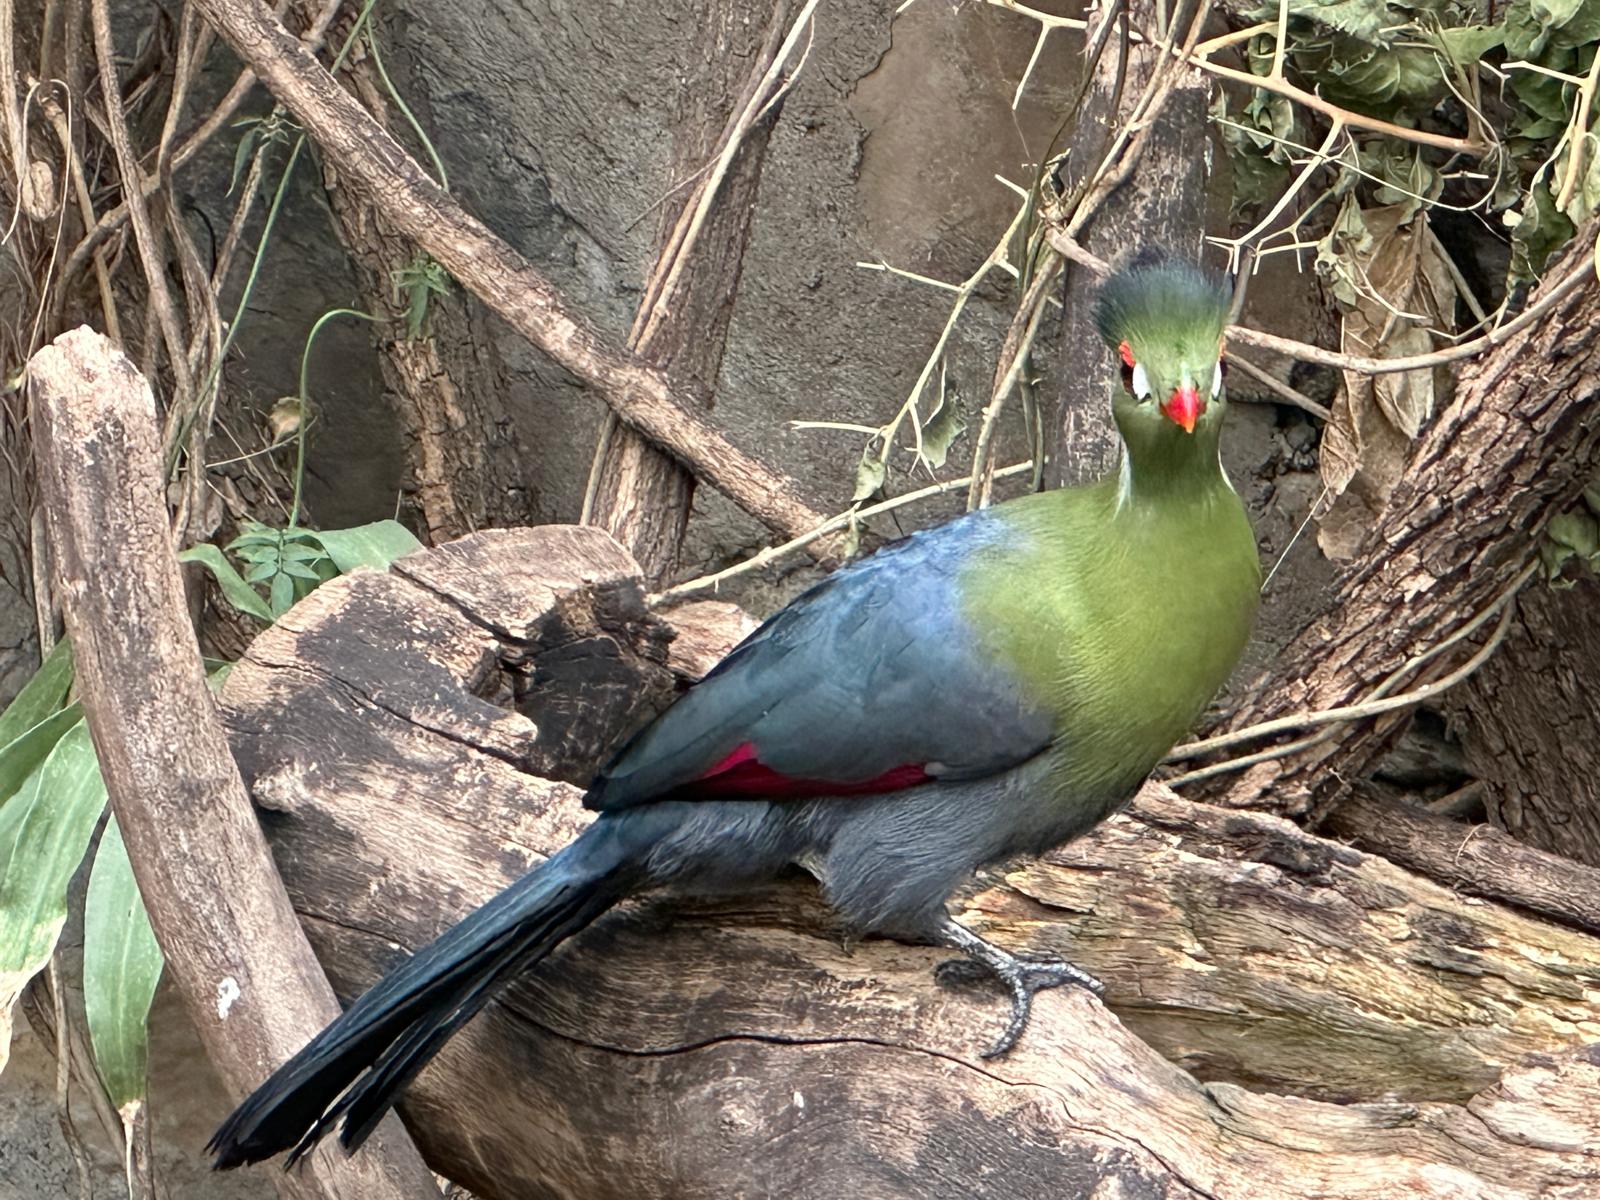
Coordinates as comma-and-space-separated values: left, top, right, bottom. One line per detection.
83, 818, 162, 1112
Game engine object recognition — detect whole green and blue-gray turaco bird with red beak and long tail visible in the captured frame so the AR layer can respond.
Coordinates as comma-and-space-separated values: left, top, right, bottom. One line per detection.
210, 262, 1261, 1168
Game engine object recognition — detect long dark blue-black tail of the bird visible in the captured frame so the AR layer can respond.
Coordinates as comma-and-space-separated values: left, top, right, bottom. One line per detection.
206, 814, 656, 1170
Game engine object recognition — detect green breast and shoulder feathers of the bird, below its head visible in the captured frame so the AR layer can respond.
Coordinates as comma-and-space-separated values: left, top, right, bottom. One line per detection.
963, 472, 1261, 808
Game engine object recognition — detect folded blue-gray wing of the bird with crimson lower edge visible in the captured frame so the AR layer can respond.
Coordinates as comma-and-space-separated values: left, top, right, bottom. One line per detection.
584, 510, 1054, 810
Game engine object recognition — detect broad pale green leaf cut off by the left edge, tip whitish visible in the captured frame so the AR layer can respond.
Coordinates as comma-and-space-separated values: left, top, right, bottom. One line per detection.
0, 722, 106, 1067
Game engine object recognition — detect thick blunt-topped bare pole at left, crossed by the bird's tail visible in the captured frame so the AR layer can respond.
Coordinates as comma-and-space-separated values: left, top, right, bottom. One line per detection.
29, 328, 434, 1200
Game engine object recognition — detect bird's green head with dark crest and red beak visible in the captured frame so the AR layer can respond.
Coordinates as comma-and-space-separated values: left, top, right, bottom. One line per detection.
1094, 261, 1229, 462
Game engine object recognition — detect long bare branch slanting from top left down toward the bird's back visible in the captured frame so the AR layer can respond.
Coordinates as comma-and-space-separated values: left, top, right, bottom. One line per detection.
190, 0, 824, 536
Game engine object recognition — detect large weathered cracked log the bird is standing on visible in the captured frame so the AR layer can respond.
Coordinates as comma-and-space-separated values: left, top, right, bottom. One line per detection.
224, 528, 1600, 1200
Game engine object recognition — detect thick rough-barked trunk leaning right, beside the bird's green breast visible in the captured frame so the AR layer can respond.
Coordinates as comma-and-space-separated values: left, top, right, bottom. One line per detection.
1208, 226, 1600, 813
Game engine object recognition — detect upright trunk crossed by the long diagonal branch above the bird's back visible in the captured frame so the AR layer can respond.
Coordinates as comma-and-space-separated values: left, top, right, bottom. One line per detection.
586, 0, 794, 587
